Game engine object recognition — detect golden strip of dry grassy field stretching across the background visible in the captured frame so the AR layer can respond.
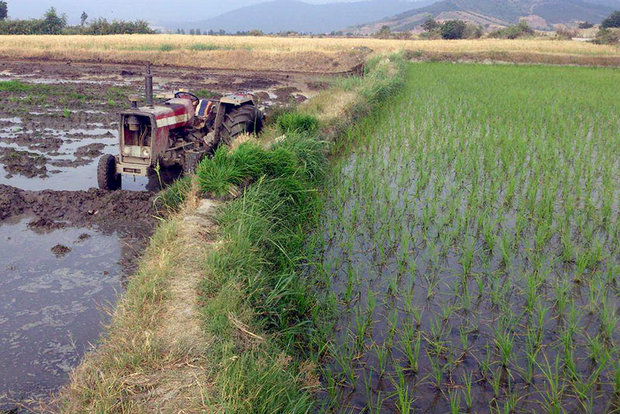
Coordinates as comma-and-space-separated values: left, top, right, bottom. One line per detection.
0, 35, 620, 73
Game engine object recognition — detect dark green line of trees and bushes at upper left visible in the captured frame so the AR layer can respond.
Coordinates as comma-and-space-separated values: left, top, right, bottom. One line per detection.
0, 5, 156, 35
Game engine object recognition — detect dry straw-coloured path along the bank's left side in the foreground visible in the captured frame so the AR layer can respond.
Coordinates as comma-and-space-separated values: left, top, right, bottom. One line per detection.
58, 189, 222, 413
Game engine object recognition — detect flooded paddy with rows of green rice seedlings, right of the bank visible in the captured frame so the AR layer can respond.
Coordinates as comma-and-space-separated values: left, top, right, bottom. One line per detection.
315, 63, 620, 413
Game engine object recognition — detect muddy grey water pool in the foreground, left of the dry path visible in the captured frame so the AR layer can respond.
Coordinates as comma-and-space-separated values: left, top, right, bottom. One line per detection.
0, 218, 122, 409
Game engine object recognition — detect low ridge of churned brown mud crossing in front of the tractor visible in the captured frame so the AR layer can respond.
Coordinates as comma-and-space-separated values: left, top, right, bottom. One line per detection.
0, 184, 156, 234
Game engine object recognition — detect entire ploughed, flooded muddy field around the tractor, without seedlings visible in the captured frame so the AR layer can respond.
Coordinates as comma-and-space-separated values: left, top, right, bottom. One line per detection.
0, 61, 324, 410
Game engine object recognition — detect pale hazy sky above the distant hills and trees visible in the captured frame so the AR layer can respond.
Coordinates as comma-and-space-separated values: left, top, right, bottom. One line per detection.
6, 0, 414, 23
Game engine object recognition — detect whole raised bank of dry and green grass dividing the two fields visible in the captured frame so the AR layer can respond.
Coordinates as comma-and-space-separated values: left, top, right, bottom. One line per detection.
55, 54, 400, 412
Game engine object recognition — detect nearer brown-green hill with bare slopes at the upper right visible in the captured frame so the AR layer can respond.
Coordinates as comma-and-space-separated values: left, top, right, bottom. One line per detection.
354, 0, 620, 33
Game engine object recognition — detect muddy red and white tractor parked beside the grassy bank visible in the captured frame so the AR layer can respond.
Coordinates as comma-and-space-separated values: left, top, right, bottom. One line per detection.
97, 63, 264, 190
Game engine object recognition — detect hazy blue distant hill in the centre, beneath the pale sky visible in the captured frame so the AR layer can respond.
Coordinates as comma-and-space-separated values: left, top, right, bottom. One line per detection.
165, 0, 429, 33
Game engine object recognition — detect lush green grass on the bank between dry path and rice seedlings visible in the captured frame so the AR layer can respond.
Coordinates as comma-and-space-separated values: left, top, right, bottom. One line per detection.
197, 135, 325, 413
